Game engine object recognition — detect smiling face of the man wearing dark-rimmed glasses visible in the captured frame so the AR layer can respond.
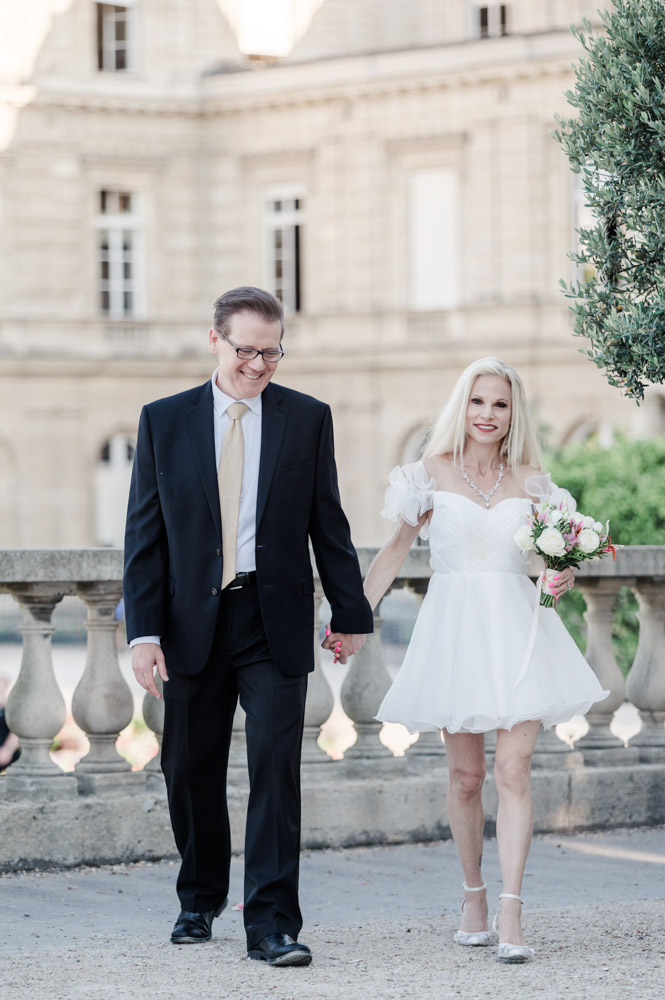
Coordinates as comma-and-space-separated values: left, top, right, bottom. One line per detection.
209, 312, 281, 399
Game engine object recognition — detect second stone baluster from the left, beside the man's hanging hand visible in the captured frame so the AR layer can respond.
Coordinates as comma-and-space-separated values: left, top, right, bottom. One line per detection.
72, 581, 134, 790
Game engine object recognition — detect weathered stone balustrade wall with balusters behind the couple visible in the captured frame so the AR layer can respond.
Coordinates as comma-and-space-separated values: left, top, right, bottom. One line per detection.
0, 546, 665, 870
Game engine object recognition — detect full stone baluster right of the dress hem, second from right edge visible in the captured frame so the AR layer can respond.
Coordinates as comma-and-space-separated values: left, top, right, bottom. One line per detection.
575, 577, 637, 765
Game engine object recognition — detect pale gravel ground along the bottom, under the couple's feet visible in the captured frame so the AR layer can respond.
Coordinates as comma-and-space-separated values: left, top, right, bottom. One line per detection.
2, 903, 665, 1000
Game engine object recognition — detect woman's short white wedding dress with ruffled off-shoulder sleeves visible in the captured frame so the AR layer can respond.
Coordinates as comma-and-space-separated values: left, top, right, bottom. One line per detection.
377, 462, 609, 733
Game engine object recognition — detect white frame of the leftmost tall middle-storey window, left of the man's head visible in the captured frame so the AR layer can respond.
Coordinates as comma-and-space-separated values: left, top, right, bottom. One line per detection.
95, 187, 145, 320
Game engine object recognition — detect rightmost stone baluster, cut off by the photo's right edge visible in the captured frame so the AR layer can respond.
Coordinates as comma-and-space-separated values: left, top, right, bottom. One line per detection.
626, 578, 665, 763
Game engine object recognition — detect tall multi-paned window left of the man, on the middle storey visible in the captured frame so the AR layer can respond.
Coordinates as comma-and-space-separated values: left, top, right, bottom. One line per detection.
97, 191, 143, 319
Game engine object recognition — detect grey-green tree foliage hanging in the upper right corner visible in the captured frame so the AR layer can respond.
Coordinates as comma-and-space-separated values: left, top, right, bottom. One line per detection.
554, 0, 665, 400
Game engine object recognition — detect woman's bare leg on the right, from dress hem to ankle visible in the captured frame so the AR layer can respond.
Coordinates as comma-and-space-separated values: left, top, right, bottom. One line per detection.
494, 722, 540, 944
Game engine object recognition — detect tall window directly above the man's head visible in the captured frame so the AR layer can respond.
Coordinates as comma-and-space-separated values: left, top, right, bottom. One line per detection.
265, 191, 304, 314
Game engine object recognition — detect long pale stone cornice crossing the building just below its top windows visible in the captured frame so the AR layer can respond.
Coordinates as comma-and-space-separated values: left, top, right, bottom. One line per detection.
0, 32, 579, 118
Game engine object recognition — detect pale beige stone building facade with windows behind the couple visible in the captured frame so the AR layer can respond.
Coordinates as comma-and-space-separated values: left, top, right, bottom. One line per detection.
0, 0, 664, 546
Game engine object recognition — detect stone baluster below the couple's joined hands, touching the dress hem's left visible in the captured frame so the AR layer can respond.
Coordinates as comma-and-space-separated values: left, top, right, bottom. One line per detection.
341, 596, 396, 768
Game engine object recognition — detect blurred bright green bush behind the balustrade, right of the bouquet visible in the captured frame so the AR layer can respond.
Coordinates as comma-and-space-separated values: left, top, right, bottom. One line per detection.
546, 437, 665, 674
